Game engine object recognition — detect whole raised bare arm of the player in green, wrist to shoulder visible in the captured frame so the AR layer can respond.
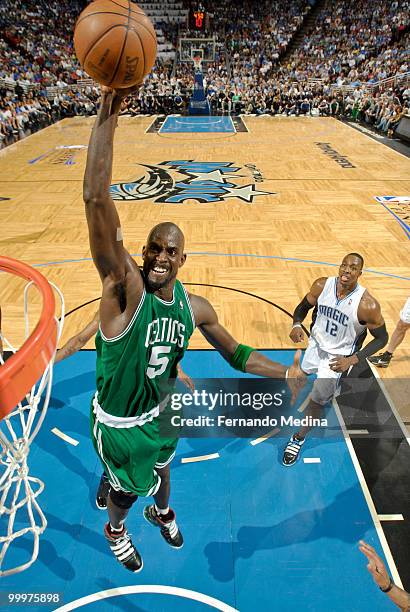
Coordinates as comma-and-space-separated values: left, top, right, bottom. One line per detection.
83, 88, 143, 337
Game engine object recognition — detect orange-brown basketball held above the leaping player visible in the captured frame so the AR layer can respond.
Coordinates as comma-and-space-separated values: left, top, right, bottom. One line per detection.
74, 0, 157, 89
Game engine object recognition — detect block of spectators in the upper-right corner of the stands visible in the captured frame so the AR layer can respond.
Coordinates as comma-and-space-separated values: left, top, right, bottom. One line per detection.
283, 0, 410, 84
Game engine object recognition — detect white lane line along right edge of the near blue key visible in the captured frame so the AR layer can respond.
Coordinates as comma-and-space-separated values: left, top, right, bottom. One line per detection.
332, 399, 403, 588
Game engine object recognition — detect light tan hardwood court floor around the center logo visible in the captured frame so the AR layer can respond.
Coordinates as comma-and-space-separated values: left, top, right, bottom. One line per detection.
0, 117, 410, 416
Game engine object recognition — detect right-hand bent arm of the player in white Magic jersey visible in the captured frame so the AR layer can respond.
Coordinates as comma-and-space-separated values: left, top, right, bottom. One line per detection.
329, 291, 389, 372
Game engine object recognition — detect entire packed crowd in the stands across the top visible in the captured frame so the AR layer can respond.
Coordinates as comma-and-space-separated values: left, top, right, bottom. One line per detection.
0, 0, 410, 146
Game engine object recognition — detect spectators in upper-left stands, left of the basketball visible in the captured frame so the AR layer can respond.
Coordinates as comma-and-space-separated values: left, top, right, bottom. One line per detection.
0, 0, 89, 144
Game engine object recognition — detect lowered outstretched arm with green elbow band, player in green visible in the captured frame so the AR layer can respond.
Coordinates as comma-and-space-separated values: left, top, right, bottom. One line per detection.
190, 295, 306, 400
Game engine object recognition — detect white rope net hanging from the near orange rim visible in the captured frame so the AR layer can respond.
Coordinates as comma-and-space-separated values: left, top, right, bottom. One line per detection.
0, 282, 64, 576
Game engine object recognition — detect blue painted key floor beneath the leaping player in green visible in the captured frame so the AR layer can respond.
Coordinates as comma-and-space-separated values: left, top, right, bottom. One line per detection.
0, 350, 395, 612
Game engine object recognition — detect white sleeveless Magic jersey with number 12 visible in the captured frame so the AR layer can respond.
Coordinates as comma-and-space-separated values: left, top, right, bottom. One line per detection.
312, 276, 366, 355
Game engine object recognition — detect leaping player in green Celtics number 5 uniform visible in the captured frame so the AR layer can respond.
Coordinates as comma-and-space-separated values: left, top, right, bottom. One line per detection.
83, 83, 305, 572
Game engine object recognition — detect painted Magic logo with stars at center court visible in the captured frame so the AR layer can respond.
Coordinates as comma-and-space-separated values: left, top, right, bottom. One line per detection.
111, 159, 274, 204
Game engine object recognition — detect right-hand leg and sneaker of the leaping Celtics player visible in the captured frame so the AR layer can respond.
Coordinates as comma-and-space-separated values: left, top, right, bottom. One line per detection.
144, 439, 184, 548
